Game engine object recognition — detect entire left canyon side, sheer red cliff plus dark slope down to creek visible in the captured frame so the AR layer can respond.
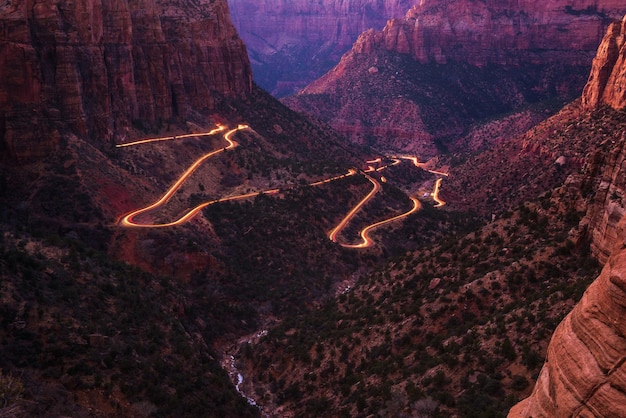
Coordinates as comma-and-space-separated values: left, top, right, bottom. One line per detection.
0, 0, 388, 417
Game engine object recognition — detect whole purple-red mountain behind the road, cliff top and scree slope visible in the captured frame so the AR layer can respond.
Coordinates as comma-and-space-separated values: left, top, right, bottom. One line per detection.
285, 1, 626, 156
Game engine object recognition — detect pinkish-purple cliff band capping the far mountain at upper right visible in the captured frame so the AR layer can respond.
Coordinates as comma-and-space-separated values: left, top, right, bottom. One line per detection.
305, 0, 626, 93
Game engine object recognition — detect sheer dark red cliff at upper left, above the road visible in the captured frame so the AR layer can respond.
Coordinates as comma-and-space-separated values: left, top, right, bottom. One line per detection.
0, 0, 251, 159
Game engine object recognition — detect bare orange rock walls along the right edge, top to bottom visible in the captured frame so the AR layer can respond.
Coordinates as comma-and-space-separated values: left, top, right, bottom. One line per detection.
509, 14, 626, 418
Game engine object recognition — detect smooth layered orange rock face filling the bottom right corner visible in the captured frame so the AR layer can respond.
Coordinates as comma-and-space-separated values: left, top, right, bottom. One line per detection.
509, 248, 626, 418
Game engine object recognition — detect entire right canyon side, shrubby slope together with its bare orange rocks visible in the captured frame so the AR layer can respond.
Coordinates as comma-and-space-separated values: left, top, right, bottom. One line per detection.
229, 11, 626, 417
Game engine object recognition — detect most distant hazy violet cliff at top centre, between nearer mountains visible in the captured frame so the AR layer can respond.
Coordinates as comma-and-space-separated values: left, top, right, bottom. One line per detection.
229, 0, 417, 97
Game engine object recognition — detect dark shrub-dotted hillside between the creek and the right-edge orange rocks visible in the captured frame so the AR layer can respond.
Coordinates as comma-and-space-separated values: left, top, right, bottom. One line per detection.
237, 102, 626, 417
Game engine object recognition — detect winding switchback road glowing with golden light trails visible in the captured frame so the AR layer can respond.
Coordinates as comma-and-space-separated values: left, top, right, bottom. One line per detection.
117, 125, 448, 248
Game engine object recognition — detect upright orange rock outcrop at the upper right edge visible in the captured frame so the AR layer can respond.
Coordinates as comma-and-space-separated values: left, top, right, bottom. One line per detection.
583, 17, 626, 110
